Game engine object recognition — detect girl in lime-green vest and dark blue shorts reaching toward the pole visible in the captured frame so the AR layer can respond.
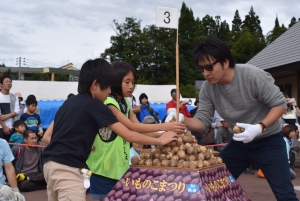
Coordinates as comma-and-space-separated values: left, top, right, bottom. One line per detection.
87, 62, 185, 200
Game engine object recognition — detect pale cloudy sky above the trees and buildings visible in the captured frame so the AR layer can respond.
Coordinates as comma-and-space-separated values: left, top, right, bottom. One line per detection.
0, 0, 300, 69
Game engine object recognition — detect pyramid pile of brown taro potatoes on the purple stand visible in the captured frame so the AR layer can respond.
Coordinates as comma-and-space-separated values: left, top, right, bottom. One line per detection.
131, 131, 223, 169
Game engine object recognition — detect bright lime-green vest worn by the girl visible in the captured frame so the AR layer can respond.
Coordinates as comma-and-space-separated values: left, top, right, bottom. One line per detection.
86, 97, 130, 180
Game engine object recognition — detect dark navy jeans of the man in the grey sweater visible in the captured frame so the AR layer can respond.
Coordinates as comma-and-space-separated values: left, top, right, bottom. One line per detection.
221, 132, 299, 201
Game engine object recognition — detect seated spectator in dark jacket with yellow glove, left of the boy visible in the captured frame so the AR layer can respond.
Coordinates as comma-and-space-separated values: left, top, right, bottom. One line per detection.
12, 130, 47, 192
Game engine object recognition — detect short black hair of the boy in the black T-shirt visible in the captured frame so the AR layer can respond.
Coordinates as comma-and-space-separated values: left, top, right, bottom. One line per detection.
77, 58, 114, 94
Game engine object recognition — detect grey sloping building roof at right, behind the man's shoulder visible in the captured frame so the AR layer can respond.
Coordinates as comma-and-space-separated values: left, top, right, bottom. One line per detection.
247, 22, 300, 70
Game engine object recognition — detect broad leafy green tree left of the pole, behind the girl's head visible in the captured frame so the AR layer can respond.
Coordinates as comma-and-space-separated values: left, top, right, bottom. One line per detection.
101, 18, 176, 84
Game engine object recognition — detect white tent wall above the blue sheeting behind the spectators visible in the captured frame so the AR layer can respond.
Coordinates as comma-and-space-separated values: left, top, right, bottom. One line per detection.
11, 80, 183, 103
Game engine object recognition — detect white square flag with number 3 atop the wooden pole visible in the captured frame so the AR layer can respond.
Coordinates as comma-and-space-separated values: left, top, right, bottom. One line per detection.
156, 6, 178, 29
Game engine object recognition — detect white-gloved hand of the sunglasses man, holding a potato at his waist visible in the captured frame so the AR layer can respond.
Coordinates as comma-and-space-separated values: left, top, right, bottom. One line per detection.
233, 123, 262, 143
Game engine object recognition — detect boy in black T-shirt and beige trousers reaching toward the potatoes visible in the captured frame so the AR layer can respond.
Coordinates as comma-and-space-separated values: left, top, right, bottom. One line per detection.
44, 59, 176, 200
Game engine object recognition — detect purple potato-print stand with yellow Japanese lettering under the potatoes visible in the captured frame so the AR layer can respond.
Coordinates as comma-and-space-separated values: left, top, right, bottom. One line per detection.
104, 165, 250, 201
